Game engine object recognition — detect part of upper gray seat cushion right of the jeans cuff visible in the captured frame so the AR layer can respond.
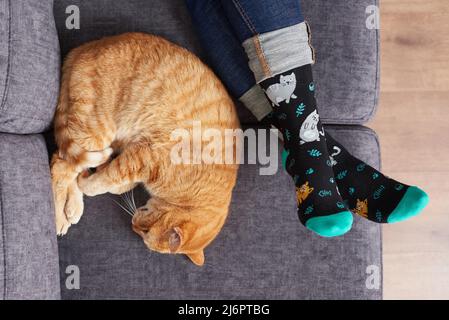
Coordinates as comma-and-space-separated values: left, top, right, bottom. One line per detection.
301, 0, 379, 124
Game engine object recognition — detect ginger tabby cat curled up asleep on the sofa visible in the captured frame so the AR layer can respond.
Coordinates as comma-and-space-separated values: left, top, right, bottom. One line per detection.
51, 33, 239, 265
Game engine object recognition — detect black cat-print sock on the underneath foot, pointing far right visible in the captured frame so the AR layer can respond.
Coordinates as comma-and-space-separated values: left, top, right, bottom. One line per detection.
278, 127, 429, 223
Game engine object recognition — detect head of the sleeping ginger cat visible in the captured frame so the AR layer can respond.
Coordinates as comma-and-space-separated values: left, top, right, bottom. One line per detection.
132, 199, 226, 266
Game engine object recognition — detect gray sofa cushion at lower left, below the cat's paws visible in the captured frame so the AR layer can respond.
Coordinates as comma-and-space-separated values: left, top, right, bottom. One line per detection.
0, 134, 60, 299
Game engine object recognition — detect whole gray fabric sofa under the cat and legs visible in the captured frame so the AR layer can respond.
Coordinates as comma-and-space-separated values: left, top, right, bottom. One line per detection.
0, 0, 382, 299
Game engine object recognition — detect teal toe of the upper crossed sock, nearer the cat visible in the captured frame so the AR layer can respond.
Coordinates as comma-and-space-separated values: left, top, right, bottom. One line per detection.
306, 211, 353, 237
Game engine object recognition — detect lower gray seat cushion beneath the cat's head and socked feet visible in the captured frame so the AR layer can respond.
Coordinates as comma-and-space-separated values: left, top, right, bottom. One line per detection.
59, 128, 381, 299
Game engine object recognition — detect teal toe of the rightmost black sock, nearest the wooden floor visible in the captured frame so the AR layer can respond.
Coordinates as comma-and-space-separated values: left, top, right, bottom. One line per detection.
387, 187, 429, 223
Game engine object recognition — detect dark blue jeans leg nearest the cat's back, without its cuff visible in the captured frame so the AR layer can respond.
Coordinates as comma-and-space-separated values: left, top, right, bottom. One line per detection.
186, 0, 255, 98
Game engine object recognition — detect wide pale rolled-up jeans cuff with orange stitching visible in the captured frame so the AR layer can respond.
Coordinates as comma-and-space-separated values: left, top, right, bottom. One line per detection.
243, 22, 314, 83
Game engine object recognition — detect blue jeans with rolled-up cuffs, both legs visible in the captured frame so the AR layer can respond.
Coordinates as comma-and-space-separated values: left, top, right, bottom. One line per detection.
186, 0, 310, 120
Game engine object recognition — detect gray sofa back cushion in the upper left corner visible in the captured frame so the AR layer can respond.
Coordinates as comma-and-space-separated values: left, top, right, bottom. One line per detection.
0, 0, 60, 133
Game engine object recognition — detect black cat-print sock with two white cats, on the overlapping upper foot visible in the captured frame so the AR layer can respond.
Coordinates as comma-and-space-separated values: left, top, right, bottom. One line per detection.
259, 65, 353, 237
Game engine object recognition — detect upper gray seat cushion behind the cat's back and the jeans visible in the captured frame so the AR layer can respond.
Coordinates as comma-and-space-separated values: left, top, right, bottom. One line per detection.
54, 0, 378, 124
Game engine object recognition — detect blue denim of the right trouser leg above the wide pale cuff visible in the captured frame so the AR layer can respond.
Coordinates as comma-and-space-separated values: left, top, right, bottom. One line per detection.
220, 0, 304, 42
